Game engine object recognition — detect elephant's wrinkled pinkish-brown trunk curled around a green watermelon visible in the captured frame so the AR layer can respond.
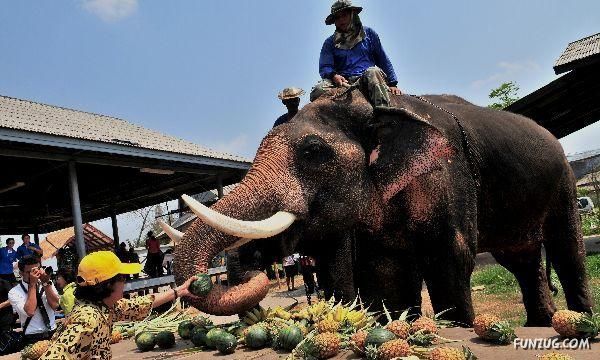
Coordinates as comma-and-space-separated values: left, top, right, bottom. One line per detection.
173, 135, 303, 315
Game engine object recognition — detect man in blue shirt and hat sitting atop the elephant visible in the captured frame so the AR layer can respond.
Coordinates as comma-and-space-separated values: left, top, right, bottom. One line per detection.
310, 0, 401, 109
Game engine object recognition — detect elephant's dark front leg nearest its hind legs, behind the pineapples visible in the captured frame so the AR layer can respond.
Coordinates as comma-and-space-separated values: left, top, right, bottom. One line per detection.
421, 232, 475, 326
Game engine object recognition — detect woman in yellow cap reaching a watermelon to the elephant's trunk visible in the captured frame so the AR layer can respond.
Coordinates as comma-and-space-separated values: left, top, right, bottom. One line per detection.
40, 251, 196, 359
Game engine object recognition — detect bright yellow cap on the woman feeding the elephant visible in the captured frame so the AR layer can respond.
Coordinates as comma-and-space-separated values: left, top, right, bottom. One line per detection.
77, 251, 142, 286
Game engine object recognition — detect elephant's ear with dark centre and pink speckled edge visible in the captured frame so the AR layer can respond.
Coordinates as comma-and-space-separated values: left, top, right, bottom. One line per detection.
368, 108, 456, 202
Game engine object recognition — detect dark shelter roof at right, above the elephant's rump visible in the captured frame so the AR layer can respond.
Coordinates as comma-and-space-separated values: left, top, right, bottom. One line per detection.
506, 33, 600, 138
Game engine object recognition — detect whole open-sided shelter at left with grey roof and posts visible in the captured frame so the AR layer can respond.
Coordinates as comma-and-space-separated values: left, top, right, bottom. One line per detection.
0, 95, 251, 257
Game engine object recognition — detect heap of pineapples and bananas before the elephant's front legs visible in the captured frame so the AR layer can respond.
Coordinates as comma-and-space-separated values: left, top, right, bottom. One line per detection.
241, 297, 476, 360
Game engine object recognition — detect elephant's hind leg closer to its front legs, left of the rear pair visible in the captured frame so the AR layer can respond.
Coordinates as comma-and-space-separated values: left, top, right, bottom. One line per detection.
492, 245, 556, 326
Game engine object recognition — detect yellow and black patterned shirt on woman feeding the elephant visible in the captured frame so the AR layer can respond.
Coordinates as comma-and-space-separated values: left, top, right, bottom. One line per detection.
40, 295, 154, 360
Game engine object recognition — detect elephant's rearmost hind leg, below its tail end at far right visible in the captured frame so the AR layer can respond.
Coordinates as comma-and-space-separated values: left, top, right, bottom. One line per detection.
544, 188, 592, 312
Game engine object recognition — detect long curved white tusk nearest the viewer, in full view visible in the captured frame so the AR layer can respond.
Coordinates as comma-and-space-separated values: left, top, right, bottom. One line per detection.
181, 194, 296, 239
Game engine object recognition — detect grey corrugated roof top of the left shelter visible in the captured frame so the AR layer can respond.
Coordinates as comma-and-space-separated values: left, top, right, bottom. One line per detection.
0, 95, 250, 162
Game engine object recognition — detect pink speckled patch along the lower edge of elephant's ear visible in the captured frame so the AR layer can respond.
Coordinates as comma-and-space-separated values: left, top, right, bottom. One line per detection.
382, 130, 454, 203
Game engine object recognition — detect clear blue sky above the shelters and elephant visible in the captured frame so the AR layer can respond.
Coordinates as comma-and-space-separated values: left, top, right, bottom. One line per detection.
0, 0, 600, 245
